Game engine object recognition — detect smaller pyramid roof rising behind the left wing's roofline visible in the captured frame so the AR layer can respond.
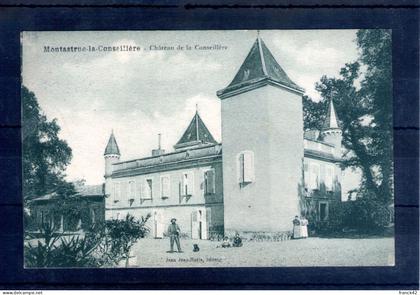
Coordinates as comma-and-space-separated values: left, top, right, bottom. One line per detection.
174, 111, 217, 149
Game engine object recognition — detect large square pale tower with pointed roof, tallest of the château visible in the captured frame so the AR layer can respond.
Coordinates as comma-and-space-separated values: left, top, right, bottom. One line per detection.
217, 36, 304, 234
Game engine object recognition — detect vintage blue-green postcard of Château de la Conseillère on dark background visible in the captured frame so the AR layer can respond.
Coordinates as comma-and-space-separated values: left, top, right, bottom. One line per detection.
21, 29, 395, 268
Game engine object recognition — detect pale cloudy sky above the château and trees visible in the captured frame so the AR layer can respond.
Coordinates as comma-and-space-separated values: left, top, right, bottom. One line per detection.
21, 30, 358, 197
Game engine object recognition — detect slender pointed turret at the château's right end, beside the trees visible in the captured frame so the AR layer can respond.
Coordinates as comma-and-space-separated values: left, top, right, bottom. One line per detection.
321, 99, 343, 158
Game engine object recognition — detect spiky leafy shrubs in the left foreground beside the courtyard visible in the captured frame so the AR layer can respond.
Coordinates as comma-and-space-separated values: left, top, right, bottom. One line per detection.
25, 215, 150, 267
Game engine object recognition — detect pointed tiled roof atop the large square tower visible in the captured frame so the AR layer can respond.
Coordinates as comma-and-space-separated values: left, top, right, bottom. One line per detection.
217, 35, 304, 99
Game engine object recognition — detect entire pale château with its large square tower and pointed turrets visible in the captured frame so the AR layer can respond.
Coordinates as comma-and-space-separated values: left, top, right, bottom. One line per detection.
104, 37, 342, 239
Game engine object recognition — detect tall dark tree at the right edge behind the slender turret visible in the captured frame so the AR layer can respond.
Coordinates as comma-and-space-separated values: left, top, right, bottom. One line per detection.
304, 30, 393, 204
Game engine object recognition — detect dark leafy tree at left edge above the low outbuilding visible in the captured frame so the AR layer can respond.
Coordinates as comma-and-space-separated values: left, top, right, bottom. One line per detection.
21, 86, 74, 202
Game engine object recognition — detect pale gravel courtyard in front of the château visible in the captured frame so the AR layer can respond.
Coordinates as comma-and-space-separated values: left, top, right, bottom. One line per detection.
130, 238, 394, 267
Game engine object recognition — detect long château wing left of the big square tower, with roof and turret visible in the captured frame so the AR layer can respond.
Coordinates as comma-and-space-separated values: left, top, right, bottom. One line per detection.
104, 113, 224, 239
